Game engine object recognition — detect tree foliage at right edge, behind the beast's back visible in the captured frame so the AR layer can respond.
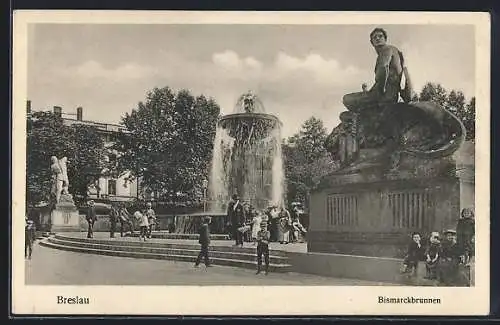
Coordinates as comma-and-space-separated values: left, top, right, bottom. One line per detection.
413, 82, 476, 141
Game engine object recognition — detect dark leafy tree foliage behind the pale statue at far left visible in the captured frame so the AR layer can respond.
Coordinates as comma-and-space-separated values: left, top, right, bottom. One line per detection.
26, 112, 104, 204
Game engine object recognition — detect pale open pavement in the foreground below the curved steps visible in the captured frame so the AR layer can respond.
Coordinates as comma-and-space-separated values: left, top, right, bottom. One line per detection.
25, 241, 398, 286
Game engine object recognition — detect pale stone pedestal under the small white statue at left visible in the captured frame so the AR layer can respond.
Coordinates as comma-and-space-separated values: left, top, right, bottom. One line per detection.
50, 194, 80, 233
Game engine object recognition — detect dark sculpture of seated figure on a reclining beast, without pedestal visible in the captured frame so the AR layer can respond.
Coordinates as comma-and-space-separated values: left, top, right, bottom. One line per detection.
325, 28, 465, 171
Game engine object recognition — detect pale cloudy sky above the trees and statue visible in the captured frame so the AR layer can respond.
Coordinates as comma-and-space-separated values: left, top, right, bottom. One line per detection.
28, 24, 475, 137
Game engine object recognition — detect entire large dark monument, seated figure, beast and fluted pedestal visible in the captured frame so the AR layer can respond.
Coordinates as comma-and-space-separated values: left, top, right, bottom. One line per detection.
307, 28, 465, 257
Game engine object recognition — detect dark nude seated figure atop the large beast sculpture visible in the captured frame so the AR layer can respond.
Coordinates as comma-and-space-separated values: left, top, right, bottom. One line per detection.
343, 28, 411, 113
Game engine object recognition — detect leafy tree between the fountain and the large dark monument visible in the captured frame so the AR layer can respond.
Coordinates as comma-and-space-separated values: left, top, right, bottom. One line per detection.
282, 117, 335, 204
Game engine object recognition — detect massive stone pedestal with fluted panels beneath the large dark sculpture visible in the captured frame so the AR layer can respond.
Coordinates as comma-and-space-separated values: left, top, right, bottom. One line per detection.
307, 152, 460, 258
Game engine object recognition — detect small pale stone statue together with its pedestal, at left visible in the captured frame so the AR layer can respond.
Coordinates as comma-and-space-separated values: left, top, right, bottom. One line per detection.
50, 156, 80, 232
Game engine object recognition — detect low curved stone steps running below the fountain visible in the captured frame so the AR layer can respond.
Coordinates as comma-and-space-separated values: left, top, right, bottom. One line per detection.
40, 235, 291, 272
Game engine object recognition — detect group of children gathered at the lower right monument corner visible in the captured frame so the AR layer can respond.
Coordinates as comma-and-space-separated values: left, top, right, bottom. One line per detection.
402, 208, 474, 285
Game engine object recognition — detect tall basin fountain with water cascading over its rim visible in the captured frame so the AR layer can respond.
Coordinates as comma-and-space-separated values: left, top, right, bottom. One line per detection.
209, 92, 284, 212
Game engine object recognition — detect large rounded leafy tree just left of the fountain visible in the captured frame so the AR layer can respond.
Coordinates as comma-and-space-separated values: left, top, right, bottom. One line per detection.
114, 87, 220, 199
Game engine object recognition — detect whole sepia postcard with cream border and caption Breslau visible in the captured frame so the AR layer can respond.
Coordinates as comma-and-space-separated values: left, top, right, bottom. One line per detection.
12, 11, 490, 314
